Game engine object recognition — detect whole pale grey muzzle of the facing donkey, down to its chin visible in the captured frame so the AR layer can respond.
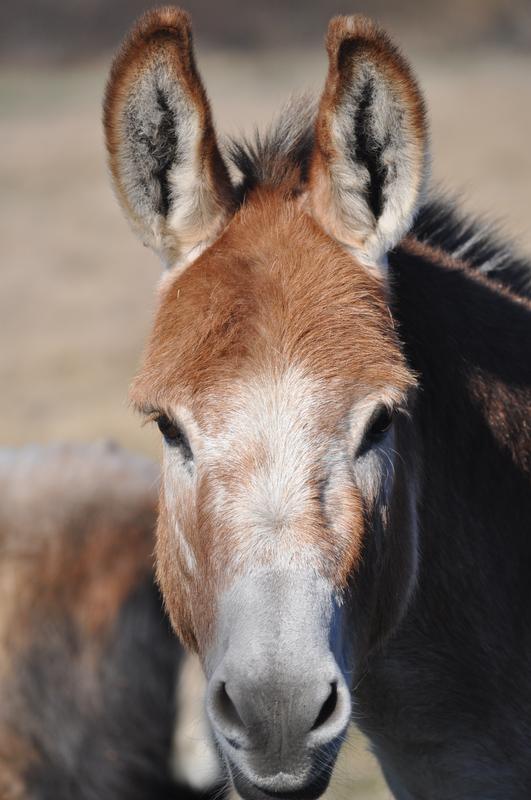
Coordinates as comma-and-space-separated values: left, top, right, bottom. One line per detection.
206, 570, 351, 800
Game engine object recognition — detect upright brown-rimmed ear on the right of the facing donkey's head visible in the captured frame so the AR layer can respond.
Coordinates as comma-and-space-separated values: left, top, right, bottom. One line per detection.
308, 17, 428, 266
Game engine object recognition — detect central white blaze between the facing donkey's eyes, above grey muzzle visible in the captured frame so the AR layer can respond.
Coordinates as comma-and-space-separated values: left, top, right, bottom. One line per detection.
205, 367, 325, 568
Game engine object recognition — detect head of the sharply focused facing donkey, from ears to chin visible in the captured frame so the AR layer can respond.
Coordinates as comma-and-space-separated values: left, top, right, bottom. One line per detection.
105, 9, 426, 798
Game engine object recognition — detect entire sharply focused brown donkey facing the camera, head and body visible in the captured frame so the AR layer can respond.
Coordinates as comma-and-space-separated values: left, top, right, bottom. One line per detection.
104, 8, 531, 800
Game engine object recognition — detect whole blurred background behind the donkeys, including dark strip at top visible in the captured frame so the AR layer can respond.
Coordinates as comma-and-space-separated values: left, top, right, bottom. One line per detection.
0, 0, 531, 800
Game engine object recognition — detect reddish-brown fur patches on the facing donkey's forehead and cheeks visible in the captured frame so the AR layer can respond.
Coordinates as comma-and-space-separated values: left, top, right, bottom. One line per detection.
132, 190, 414, 646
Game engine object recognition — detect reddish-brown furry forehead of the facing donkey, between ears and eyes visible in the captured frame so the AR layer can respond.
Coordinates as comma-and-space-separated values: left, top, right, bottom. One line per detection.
132, 197, 413, 414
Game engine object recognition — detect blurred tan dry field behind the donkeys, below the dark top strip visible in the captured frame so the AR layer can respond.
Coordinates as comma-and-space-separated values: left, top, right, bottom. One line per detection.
0, 40, 531, 800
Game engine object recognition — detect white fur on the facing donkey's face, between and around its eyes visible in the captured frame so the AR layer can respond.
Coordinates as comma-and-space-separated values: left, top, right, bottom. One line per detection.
160, 366, 403, 574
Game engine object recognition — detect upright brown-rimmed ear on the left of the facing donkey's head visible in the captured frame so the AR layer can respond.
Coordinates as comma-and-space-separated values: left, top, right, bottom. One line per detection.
104, 7, 233, 266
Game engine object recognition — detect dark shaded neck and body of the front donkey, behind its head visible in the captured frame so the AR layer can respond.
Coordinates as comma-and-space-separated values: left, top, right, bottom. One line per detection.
358, 238, 531, 799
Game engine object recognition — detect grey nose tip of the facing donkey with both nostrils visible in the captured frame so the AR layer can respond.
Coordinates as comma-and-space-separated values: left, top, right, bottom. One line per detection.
209, 674, 350, 756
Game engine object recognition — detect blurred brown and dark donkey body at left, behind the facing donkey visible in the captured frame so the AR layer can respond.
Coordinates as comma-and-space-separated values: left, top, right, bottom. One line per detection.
0, 445, 221, 800
